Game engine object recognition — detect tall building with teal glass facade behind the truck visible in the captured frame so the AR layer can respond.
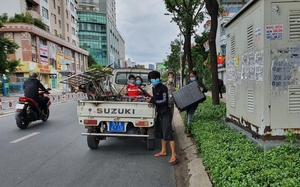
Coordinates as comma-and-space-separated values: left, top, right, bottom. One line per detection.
77, 0, 125, 67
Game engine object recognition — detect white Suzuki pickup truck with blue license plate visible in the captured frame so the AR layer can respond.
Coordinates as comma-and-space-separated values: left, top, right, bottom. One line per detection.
77, 68, 156, 150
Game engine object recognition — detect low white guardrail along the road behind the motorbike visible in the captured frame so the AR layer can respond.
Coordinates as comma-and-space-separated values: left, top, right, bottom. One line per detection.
0, 93, 87, 115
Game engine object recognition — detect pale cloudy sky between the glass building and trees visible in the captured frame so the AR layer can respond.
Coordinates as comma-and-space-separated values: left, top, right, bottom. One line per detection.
116, 0, 190, 64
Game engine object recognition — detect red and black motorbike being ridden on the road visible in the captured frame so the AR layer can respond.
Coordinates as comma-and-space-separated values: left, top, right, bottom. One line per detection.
15, 89, 51, 129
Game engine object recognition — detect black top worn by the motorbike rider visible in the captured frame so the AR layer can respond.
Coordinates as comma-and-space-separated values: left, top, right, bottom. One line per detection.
24, 77, 48, 99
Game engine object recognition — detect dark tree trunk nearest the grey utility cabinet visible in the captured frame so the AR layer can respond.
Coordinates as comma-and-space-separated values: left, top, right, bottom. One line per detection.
205, 0, 220, 105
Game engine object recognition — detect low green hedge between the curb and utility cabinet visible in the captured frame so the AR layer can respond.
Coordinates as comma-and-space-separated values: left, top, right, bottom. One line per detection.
190, 97, 300, 187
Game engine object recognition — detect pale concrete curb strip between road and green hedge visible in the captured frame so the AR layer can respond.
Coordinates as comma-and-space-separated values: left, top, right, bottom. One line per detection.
173, 92, 226, 187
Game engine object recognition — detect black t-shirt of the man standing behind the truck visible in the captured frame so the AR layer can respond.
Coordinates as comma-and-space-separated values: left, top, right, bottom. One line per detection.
150, 83, 171, 115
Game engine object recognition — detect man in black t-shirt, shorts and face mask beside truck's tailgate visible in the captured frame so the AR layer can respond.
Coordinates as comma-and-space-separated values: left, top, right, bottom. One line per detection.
146, 71, 178, 164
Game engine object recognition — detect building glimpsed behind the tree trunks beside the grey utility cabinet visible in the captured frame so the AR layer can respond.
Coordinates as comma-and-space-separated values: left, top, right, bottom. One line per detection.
203, 0, 248, 82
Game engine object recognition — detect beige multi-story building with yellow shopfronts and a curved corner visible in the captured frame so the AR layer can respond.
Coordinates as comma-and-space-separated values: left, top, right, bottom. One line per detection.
0, 0, 88, 93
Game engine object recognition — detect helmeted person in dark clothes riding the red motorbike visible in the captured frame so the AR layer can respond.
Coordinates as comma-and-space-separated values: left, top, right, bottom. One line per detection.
24, 72, 50, 117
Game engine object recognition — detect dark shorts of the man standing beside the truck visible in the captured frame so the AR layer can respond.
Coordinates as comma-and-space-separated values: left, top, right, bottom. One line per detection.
155, 113, 174, 141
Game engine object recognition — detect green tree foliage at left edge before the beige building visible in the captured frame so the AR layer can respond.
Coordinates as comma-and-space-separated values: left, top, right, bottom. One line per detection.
0, 19, 20, 75
